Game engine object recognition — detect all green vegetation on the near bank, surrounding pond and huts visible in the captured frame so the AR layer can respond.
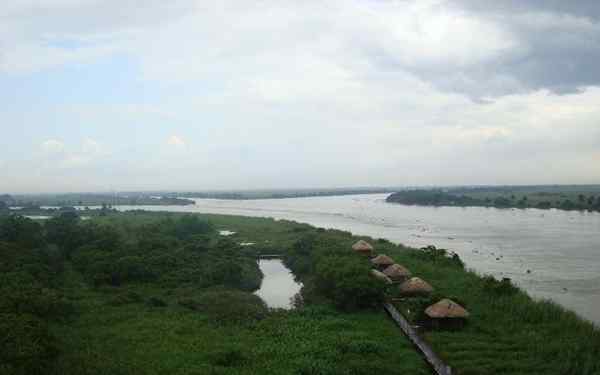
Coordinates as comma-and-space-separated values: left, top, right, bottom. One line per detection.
0, 211, 600, 375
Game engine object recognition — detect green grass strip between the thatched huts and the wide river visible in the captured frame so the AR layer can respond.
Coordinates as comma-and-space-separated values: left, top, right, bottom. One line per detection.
185, 216, 600, 375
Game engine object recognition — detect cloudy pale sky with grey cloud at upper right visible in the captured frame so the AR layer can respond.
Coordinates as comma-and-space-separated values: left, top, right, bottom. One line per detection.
0, 0, 600, 193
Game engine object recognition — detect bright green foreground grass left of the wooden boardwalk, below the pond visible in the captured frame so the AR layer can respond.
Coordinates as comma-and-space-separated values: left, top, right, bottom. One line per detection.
50, 288, 429, 374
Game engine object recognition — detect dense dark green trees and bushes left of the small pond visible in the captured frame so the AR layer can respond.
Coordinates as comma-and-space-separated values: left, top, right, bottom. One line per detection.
0, 212, 261, 374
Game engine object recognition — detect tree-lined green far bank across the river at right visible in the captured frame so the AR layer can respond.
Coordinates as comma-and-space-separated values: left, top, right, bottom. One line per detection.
387, 186, 600, 211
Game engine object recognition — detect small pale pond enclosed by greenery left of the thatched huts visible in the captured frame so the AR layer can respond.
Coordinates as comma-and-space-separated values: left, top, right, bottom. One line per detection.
255, 259, 302, 309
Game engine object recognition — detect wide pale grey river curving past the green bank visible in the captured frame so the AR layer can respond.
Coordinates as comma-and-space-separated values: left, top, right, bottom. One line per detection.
109, 194, 600, 325
